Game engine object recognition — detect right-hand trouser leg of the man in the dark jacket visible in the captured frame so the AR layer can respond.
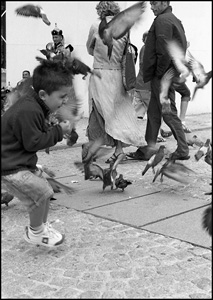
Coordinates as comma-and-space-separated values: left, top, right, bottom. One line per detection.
163, 88, 189, 159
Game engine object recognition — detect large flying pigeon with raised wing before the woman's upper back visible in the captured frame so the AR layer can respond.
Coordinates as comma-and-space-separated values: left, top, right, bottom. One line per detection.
98, 1, 146, 59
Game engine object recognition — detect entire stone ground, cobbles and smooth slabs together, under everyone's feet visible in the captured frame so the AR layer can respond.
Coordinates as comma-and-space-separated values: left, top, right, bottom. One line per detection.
1, 114, 212, 299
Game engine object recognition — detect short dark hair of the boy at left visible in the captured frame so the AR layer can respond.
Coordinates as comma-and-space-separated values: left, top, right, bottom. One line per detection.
32, 59, 73, 95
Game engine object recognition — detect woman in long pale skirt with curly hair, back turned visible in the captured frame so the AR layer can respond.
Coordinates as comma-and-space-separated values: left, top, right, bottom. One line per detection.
86, 1, 144, 163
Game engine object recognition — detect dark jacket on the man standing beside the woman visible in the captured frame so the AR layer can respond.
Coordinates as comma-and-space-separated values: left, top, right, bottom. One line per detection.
143, 6, 187, 82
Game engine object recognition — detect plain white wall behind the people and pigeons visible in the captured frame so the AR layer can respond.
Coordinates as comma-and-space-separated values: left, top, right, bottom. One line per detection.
6, 1, 212, 117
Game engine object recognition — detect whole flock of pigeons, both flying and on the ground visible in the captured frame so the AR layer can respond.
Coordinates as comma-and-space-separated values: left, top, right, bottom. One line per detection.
1, 1, 212, 235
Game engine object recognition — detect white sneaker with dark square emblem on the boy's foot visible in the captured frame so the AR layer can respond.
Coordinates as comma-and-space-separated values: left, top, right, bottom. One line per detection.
24, 225, 65, 247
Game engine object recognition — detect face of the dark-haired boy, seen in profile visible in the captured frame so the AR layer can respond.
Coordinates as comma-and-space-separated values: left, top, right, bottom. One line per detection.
39, 86, 72, 113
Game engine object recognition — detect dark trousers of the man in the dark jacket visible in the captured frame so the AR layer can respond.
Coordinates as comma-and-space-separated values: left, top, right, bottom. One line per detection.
145, 77, 189, 155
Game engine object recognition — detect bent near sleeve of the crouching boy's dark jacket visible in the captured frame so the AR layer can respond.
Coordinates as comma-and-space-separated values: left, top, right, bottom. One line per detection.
13, 110, 63, 152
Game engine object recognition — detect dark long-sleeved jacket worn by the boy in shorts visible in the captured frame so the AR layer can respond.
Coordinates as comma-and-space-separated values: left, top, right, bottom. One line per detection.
1, 89, 63, 175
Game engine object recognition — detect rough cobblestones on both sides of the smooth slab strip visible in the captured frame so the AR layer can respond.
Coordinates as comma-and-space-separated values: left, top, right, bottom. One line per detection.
1, 114, 212, 299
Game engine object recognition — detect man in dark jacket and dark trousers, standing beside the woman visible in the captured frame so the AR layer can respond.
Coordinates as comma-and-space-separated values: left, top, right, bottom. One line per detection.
126, 1, 189, 160
